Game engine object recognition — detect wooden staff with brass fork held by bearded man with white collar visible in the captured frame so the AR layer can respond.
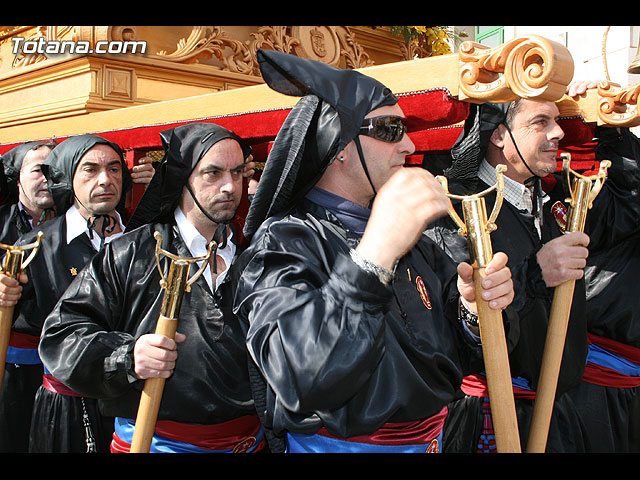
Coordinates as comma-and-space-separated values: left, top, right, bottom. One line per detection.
130, 232, 217, 453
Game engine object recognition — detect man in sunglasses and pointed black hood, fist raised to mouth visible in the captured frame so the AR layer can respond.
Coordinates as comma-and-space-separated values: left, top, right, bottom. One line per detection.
235, 51, 512, 452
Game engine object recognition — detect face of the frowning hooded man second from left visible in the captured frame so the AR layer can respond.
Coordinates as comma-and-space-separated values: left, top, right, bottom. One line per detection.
73, 144, 122, 218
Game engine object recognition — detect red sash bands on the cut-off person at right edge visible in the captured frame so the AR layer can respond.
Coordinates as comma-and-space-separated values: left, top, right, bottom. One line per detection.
582, 333, 640, 388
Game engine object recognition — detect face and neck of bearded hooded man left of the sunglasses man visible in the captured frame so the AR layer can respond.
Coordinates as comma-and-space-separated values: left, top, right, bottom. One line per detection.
180, 139, 244, 238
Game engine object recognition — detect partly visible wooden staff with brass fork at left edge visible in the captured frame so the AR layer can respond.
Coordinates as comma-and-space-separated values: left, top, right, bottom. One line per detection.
0, 232, 44, 389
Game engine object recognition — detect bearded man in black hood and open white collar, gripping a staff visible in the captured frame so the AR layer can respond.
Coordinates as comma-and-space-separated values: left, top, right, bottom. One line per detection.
40, 123, 265, 453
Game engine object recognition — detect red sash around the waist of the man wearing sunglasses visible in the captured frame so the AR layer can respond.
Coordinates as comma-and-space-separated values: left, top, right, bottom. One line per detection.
317, 407, 448, 445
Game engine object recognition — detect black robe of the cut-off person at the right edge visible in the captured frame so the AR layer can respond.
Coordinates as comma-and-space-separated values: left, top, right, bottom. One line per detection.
569, 129, 640, 453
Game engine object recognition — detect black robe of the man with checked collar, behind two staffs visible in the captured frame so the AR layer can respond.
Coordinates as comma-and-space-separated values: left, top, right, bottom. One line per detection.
426, 182, 587, 392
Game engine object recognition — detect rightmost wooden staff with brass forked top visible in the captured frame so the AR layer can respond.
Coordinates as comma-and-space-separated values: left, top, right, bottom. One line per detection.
527, 153, 611, 453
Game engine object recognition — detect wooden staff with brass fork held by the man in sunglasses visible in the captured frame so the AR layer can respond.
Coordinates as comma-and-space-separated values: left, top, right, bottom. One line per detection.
437, 165, 521, 453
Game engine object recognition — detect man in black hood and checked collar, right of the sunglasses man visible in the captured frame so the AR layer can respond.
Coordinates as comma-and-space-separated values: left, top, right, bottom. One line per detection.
426, 95, 640, 453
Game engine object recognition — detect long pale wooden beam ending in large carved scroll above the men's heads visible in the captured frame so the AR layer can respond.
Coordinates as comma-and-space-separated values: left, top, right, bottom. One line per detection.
0, 35, 573, 148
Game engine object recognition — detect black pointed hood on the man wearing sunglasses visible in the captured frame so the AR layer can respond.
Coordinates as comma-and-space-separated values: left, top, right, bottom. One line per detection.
244, 50, 398, 239
